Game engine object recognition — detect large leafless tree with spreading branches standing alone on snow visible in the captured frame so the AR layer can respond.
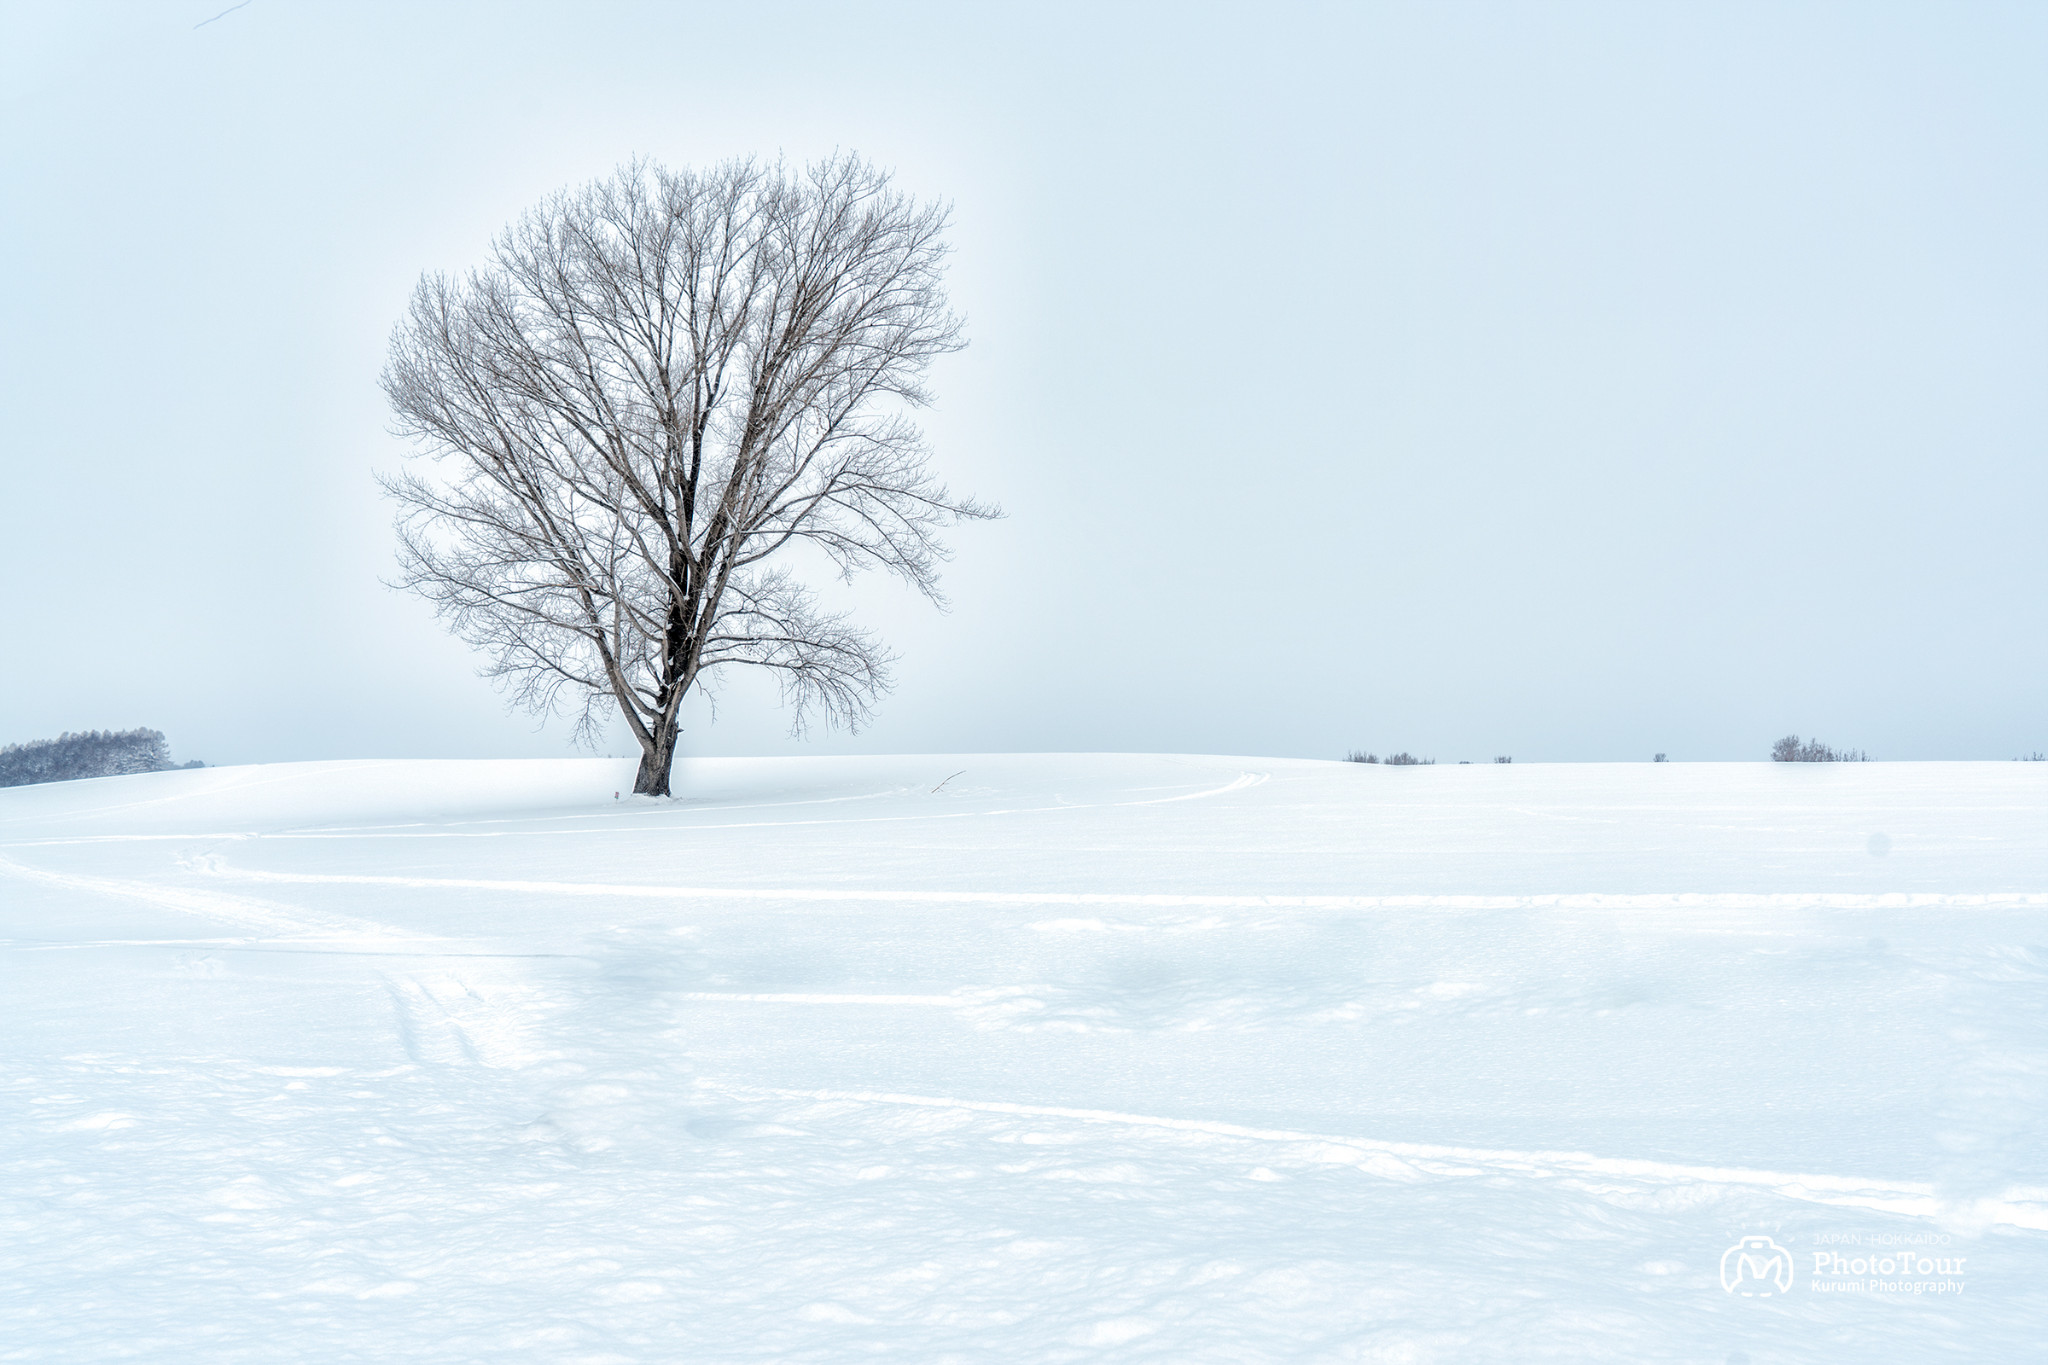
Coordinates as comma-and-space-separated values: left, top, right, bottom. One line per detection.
383, 156, 999, 796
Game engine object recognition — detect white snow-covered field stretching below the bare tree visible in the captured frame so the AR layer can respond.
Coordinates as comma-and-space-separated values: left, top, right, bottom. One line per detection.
0, 755, 2048, 1365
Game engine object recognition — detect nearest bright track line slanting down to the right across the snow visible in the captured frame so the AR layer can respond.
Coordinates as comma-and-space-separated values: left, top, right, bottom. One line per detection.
745, 1087, 2048, 1232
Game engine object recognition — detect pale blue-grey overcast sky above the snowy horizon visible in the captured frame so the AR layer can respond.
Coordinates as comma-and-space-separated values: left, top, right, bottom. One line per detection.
0, 0, 2048, 763
